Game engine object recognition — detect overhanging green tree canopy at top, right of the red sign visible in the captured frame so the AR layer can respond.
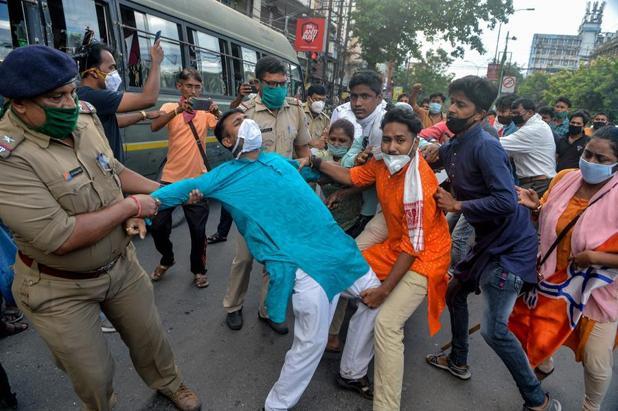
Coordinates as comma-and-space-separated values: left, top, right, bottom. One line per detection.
352, 0, 513, 68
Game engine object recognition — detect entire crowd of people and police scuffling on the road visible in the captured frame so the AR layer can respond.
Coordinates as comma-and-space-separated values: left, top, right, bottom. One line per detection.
0, 37, 618, 411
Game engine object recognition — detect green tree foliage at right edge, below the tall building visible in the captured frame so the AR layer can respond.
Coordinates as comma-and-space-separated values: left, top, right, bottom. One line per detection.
519, 58, 618, 121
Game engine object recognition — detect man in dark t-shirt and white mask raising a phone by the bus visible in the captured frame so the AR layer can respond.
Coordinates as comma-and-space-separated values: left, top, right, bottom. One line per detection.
77, 41, 163, 163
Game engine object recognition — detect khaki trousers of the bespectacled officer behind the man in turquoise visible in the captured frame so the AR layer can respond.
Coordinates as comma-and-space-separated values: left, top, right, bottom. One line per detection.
223, 234, 268, 317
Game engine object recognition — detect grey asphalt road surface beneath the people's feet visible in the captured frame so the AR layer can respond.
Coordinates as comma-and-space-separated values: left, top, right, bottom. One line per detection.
0, 206, 618, 411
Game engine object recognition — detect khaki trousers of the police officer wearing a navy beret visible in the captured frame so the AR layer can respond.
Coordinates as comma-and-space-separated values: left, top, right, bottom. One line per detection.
13, 244, 182, 411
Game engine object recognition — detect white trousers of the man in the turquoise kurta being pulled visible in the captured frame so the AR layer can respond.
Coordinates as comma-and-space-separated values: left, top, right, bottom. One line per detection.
264, 269, 380, 411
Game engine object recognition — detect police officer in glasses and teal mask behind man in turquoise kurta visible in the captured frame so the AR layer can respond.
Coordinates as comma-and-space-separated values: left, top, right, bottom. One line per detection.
223, 56, 311, 334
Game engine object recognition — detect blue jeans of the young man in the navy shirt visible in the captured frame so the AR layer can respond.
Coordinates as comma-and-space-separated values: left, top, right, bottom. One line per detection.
446, 262, 545, 407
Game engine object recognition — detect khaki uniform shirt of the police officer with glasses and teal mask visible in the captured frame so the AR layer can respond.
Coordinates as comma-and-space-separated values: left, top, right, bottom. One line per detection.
238, 95, 311, 158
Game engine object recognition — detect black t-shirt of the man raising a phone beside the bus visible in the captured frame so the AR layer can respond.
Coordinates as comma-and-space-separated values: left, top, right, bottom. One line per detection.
77, 86, 125, 163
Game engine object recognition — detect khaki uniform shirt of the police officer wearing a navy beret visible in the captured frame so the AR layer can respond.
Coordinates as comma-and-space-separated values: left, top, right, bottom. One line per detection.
0, 102, 130, 272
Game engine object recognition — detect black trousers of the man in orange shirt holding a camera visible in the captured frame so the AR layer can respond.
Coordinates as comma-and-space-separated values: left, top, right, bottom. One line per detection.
150, 200, 209, 274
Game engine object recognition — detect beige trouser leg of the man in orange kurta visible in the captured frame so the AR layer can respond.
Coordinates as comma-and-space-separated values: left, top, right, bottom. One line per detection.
373, 271, 427, 411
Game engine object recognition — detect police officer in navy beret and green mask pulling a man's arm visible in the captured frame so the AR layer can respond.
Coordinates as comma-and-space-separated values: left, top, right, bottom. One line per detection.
0, 46, 200, 411
